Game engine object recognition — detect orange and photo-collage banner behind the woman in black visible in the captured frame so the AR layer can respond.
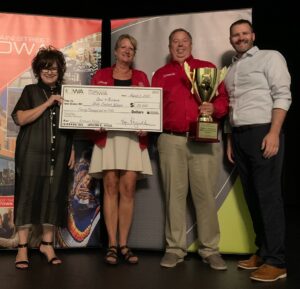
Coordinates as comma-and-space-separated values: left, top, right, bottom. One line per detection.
0, 13, 102, 248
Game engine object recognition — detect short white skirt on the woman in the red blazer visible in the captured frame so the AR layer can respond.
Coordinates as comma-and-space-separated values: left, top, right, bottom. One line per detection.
89, 131, 152, 179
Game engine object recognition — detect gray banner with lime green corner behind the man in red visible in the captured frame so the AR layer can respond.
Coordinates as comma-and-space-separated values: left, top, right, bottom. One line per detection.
111, 9, 255, 253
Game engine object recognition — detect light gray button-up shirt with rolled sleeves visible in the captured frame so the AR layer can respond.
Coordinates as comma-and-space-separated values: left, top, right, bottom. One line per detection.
225, 46, 292, 126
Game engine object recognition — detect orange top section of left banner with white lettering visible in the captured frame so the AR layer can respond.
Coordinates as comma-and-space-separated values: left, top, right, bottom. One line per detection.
0, 13, 102, 90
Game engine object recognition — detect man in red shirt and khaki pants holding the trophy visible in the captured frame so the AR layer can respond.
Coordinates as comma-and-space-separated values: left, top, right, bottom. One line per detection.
152, 28, 228, 270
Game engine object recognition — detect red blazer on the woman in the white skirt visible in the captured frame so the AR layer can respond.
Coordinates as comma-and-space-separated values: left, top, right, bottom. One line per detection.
90, 66, 150, 150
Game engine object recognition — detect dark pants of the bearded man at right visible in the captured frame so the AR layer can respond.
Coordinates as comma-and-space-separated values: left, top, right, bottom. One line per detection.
232, 124, 285, 267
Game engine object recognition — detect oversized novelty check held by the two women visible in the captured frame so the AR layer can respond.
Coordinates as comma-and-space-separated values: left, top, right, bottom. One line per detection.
59, 85, 162, 132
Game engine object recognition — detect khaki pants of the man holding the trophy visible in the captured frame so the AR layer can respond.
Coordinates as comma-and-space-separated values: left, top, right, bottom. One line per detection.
158, 133, 221, 258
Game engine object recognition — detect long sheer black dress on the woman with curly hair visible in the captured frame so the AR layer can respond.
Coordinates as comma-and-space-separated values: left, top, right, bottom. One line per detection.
12, 82, 72, 226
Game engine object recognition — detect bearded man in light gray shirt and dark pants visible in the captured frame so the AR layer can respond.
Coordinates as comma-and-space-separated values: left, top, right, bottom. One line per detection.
225, 19, 291, 282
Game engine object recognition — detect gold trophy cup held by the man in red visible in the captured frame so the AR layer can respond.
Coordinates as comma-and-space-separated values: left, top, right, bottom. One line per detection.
184, 62, 227, 142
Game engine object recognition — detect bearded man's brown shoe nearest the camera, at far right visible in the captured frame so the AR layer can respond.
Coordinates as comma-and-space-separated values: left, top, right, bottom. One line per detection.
250, 264, 286, 282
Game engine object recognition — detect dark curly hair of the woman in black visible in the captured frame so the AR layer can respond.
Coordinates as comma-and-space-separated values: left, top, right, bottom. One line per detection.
31, 45, 66, 84
